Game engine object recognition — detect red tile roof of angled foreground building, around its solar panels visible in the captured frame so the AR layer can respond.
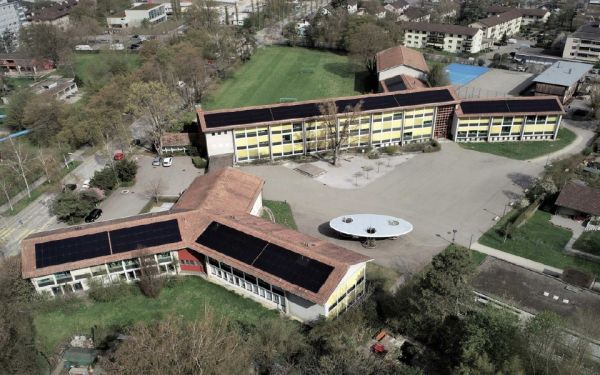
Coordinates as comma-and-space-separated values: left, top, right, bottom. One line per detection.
21, 168, 371, 304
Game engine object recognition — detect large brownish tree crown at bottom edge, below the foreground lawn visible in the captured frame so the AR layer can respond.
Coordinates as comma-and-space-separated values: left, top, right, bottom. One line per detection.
101, 308, 251, 375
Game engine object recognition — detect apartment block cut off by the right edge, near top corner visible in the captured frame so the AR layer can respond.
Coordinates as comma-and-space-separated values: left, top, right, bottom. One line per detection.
563, 22, 600, 63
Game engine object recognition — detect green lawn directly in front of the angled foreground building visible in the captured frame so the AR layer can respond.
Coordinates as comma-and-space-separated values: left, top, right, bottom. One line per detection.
33, 276, 286, 353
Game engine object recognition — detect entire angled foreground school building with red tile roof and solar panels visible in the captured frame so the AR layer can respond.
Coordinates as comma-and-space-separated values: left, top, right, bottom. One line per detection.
21, 168, 371, 321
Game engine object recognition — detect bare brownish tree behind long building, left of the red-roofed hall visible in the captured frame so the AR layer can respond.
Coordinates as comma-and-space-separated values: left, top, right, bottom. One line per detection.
346, 23, 392, 74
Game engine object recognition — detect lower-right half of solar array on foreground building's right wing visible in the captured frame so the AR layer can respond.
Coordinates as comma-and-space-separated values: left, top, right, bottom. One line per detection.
253, 244, 333, 293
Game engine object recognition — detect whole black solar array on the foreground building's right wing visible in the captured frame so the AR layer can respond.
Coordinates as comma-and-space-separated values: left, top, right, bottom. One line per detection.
196, 221, 333, 293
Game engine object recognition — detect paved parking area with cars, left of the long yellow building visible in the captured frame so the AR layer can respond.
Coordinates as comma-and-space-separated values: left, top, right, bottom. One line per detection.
98, 154, 204, 221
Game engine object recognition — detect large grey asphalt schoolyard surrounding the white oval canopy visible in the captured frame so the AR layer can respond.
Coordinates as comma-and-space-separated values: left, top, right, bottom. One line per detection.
242, 123, 591, 274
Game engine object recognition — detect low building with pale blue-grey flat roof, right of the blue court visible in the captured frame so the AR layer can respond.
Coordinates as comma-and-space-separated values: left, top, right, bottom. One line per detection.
533, 61, 594, 103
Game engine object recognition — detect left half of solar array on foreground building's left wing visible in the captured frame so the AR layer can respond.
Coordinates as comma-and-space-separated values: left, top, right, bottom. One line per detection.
35, 232, 110, 268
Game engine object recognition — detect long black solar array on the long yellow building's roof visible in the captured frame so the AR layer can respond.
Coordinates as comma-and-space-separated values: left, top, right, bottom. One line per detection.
204, 89, 454, 129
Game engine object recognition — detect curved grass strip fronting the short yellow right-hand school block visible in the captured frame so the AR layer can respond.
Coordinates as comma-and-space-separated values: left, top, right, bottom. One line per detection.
459, 127, 576, 160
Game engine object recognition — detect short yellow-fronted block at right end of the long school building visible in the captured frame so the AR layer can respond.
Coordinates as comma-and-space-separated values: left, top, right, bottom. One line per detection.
452, 97, 564, 142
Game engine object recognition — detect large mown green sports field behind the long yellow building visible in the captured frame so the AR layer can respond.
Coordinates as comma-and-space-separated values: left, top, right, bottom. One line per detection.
202, 47, 367, 109
